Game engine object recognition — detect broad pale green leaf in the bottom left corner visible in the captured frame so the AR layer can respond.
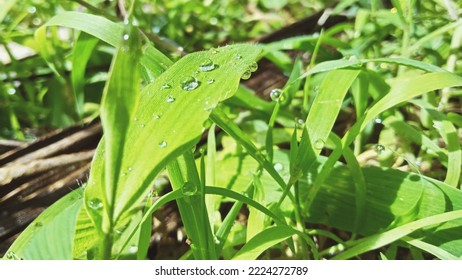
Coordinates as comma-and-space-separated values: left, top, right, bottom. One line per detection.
4, 188, 83, 260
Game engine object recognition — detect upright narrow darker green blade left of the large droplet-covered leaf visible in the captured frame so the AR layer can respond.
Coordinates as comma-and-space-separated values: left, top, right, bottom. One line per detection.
85, 21, 140, 259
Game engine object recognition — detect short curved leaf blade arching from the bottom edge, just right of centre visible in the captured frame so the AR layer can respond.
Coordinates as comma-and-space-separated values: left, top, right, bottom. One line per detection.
233, 226, 295, 260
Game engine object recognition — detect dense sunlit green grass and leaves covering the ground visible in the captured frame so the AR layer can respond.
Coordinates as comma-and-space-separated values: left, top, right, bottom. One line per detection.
0, 1, 462, 259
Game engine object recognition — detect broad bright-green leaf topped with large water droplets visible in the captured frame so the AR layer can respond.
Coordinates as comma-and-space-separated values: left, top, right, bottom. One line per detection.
81, 44, 260, 258
